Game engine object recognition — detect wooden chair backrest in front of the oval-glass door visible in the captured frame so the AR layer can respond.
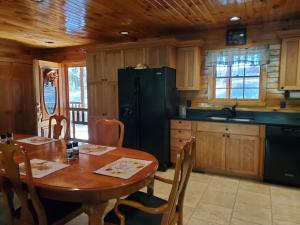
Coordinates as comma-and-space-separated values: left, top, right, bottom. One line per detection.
48, 115, 70, 140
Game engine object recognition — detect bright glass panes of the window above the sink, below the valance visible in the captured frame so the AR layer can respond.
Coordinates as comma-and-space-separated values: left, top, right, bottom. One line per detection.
214, 62, 261, 100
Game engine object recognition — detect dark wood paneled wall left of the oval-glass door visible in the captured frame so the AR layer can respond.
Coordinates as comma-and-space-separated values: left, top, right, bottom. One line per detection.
0, 40, 37, 134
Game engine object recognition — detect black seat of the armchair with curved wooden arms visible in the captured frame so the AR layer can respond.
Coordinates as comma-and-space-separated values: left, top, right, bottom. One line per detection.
104, 192, 167, 225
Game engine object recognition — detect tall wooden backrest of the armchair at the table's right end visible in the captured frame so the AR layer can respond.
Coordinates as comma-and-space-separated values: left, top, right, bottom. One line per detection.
161, 137, 196, 224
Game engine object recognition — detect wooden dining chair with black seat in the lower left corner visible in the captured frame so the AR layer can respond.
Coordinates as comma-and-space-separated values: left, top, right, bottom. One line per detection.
0, 144, 82, 225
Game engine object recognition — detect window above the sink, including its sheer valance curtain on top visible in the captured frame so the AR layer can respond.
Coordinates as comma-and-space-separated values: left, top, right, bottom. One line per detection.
206, 46, 269, 103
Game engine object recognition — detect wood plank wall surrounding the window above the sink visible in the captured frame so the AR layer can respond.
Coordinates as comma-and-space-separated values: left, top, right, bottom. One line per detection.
180, 21, 300, 111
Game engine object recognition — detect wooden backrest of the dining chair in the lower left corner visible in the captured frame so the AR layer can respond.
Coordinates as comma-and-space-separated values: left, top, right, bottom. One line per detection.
0, 144, 47, 225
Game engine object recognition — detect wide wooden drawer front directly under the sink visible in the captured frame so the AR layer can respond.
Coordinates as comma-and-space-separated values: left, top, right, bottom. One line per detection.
197, 122, 259, 136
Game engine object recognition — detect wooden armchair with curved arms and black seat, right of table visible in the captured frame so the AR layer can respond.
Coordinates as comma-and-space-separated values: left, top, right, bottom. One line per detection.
105, 137, 195, 225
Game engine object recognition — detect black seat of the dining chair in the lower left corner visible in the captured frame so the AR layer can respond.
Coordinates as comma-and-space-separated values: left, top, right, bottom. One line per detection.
16, 198, 82, 225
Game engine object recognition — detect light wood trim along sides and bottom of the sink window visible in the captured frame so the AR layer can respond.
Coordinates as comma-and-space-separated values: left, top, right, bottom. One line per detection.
208, 65, 267, 106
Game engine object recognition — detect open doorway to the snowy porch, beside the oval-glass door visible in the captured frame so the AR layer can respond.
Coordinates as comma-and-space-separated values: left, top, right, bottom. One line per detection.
67, 65, 89, 142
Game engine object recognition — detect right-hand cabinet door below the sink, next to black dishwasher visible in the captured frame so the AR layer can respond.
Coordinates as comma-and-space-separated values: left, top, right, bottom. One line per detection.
226, 135, 260, 176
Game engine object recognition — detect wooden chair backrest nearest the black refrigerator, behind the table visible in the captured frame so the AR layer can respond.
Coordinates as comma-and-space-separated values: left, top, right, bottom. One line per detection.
93, 119, 124, 147
